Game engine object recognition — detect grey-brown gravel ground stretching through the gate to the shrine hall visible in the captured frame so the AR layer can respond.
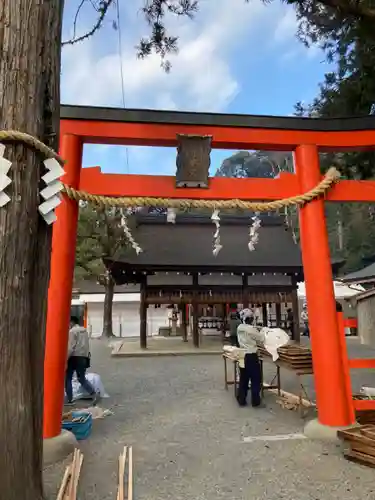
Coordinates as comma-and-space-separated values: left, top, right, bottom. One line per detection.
45, 341, 375, 500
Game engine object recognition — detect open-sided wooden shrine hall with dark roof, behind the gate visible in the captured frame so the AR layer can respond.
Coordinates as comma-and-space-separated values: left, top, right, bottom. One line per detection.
105, 213, 341, 348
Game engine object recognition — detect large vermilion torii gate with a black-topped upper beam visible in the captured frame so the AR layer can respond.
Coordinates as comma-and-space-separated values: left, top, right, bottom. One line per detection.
44, 106, 375, 438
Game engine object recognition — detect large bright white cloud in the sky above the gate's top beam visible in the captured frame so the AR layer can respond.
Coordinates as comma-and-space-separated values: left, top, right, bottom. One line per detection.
62, 0, 269, 111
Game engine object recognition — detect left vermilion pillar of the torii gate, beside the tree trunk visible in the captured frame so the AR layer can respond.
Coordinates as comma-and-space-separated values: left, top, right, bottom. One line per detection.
43, 135, 82, 438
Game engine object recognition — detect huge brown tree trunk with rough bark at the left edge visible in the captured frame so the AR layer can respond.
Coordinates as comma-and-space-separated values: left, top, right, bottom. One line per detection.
0, 0, 63, 500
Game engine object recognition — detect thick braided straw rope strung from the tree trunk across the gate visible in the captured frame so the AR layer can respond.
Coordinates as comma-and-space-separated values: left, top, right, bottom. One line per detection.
0, 130, 340, 212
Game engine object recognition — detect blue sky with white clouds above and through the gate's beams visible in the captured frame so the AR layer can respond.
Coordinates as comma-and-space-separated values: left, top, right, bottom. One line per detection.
61, 0, 334, 175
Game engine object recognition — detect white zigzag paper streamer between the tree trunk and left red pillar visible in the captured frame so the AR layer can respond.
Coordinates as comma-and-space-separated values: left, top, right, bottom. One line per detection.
38, 158, 65, 224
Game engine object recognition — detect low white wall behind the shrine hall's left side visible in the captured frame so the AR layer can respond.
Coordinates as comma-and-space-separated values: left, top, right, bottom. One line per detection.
87, 302, 168, 337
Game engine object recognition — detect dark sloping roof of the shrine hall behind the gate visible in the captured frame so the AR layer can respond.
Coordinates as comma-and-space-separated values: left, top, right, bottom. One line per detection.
105, 214, 302, 272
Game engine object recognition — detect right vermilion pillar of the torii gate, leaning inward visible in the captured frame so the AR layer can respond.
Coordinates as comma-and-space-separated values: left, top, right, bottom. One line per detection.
295, 144, 354, 427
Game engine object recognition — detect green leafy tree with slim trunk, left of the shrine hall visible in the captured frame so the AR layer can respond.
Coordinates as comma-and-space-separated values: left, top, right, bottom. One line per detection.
75, 204, 137, 338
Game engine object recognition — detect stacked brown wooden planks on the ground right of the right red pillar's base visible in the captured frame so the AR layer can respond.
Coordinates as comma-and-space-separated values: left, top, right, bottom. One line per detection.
337, 425, 375, 468
